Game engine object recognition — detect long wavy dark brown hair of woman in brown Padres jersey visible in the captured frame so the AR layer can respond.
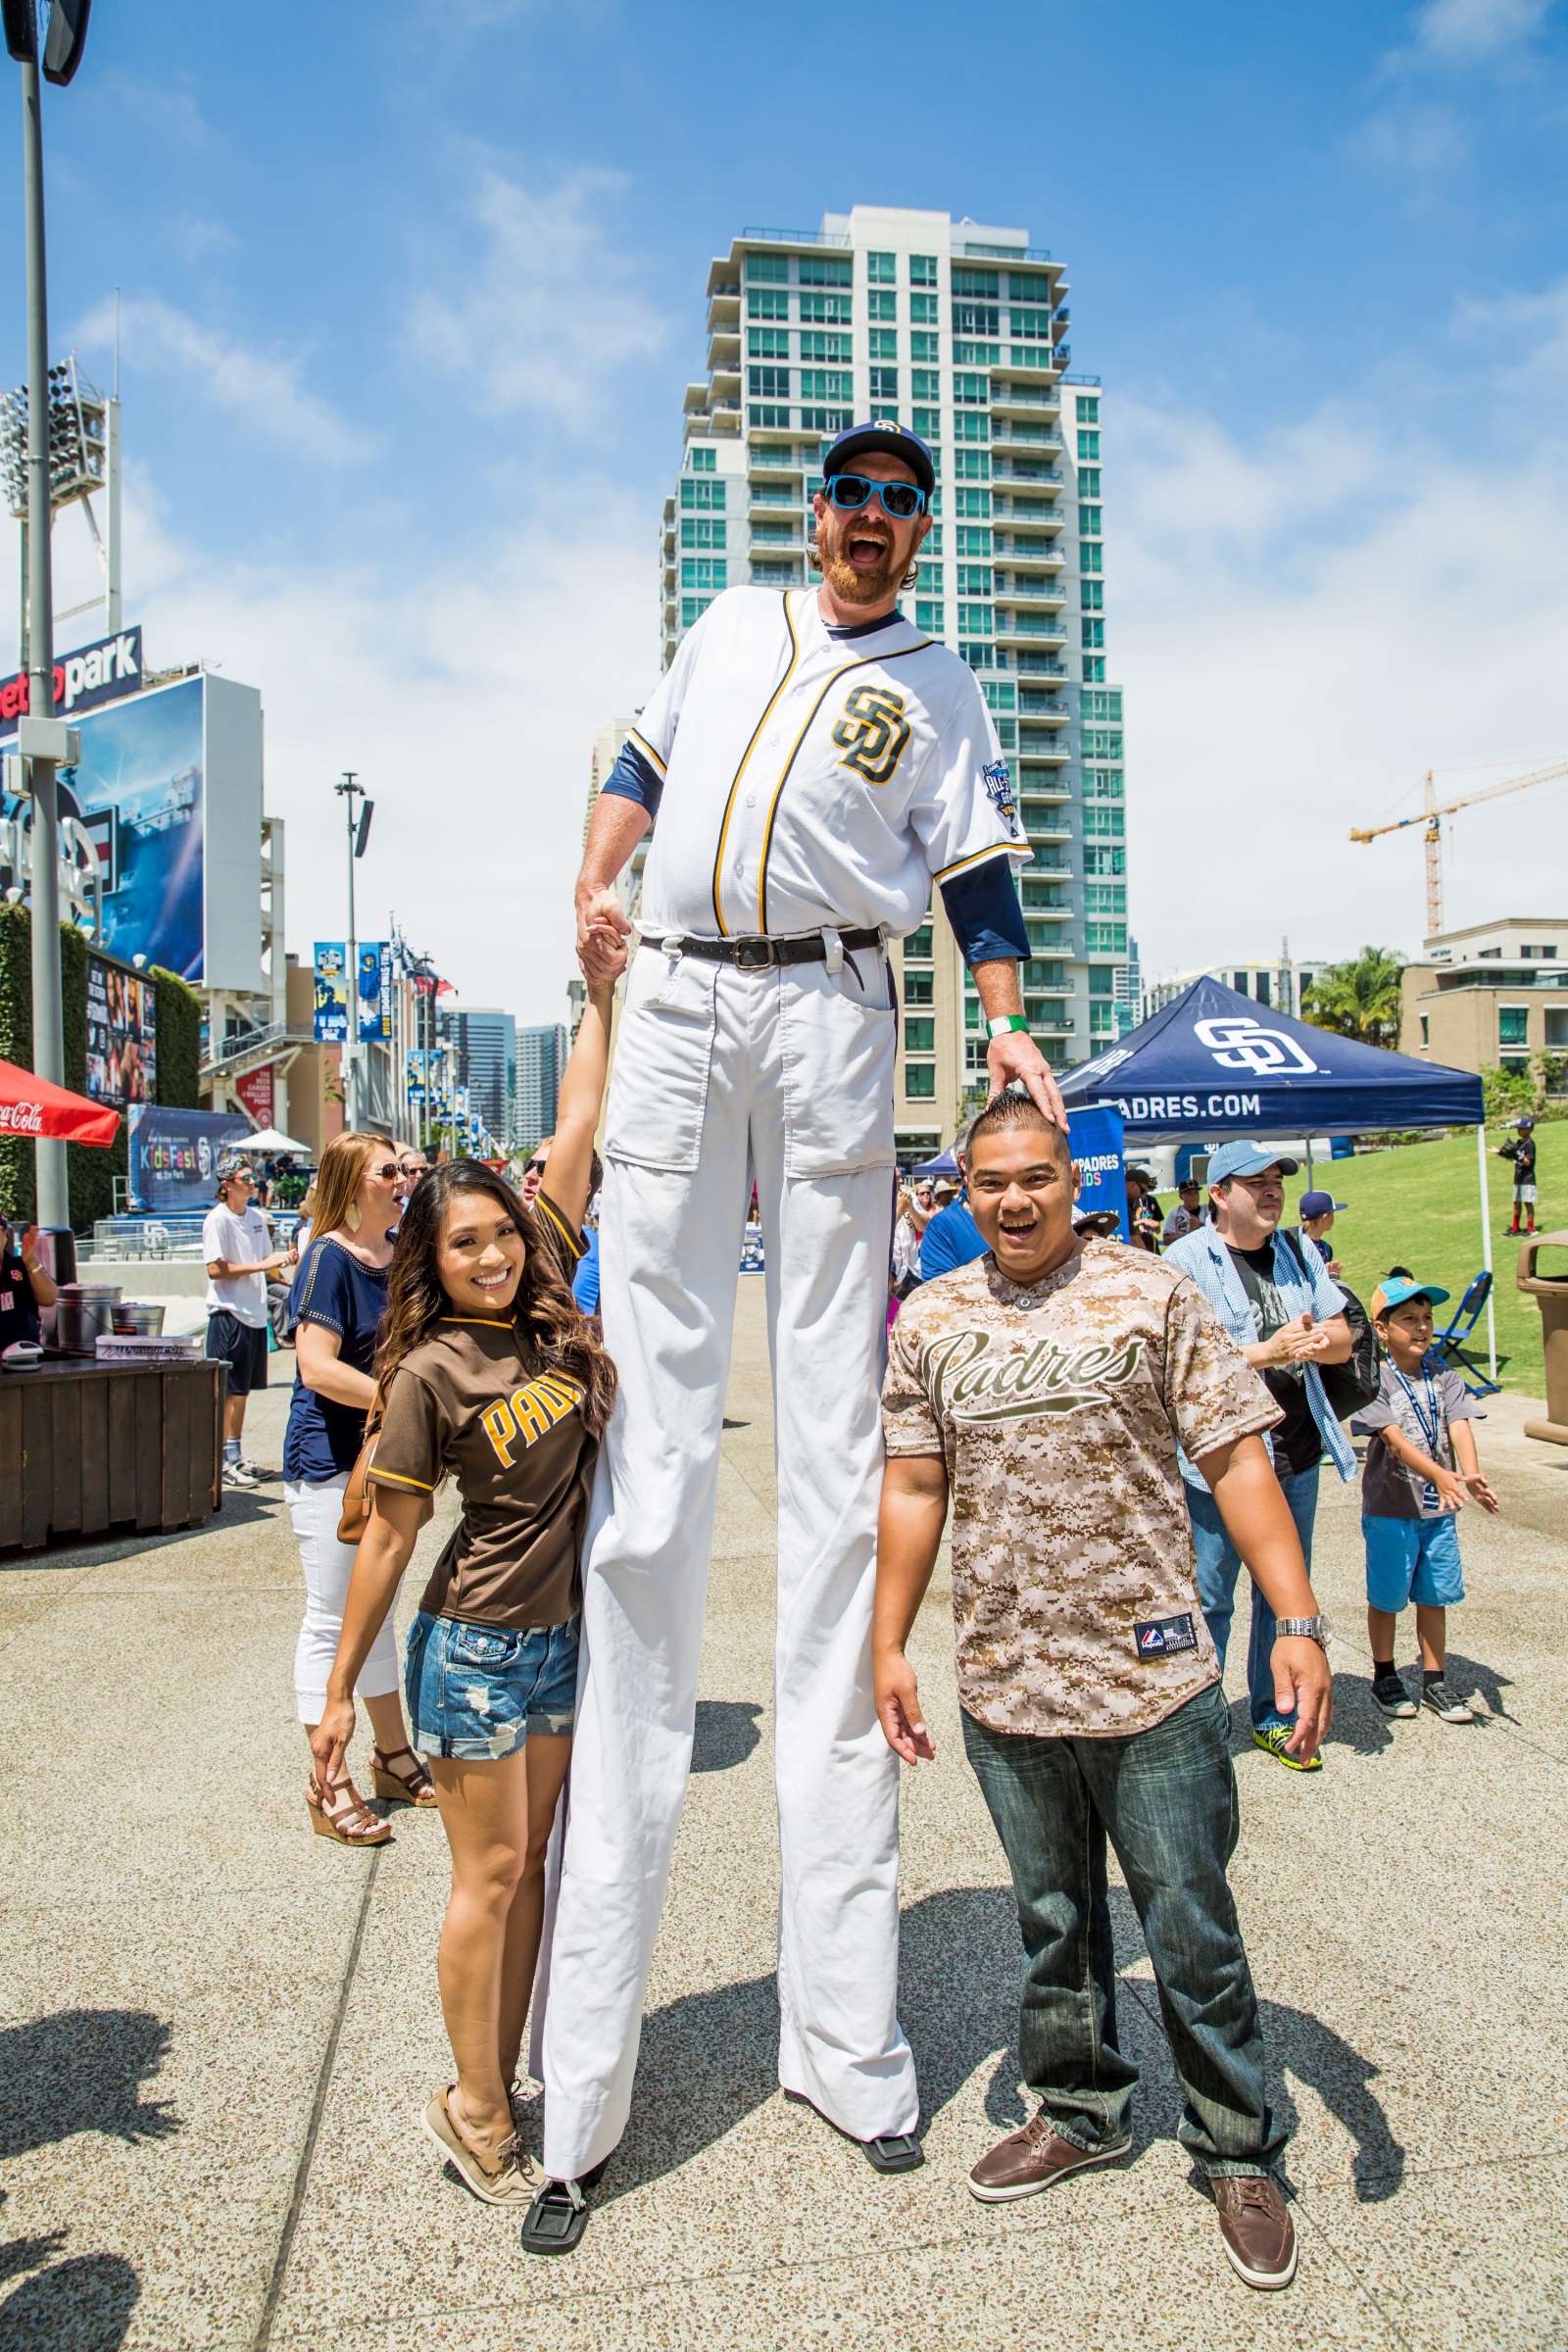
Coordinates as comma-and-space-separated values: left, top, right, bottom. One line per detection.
376, 1159, 615, 1437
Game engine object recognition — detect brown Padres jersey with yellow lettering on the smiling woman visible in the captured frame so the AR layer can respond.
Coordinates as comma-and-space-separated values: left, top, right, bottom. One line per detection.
369, 1195, 597, 1628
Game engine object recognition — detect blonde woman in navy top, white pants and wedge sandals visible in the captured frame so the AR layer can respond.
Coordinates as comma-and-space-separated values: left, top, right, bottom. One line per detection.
282, 1134, 435, 1846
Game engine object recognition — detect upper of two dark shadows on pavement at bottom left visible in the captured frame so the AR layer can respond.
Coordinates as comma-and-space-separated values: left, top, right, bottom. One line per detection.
0, 2009, 181, 2159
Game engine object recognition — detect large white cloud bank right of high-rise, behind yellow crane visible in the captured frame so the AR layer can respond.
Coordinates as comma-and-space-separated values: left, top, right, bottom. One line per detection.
1107, 287, 1568, 974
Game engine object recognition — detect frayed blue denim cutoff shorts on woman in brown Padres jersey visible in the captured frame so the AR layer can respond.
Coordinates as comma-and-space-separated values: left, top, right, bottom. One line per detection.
402, 1609, 578, 1762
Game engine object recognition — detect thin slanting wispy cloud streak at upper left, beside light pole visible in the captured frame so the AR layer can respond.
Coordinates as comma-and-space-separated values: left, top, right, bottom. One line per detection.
77, 296, 376, 466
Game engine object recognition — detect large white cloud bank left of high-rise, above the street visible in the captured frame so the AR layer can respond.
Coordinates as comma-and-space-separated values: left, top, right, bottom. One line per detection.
30, 475, 659, 1021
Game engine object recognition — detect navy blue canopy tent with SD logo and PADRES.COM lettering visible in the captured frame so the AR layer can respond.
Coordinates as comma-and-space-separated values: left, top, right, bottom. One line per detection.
1060, 978, 1497, 1378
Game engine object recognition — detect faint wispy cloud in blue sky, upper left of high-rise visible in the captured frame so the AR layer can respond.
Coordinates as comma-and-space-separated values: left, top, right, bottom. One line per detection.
407, 158, 665, 433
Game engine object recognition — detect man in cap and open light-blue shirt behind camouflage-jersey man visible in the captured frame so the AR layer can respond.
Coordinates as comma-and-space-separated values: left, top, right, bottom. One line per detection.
1166, 1139, 1356, 1771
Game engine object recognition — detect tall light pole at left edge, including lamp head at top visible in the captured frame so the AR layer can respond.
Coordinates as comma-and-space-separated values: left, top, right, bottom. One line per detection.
0, 0, 92, 1225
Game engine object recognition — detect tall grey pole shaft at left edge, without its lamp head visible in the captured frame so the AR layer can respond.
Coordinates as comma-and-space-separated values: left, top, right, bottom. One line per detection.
17, 59, 71, 1225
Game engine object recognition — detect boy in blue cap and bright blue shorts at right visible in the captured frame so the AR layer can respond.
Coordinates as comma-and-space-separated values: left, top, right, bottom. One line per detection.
1349, 1275, 1499, 1724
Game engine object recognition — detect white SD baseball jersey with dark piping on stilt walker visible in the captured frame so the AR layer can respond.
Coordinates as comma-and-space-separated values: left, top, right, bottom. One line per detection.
632, 588, 1030, 939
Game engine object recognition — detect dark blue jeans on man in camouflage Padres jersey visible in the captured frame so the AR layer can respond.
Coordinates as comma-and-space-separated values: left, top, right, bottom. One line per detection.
961, 1682, 1286, 2176
